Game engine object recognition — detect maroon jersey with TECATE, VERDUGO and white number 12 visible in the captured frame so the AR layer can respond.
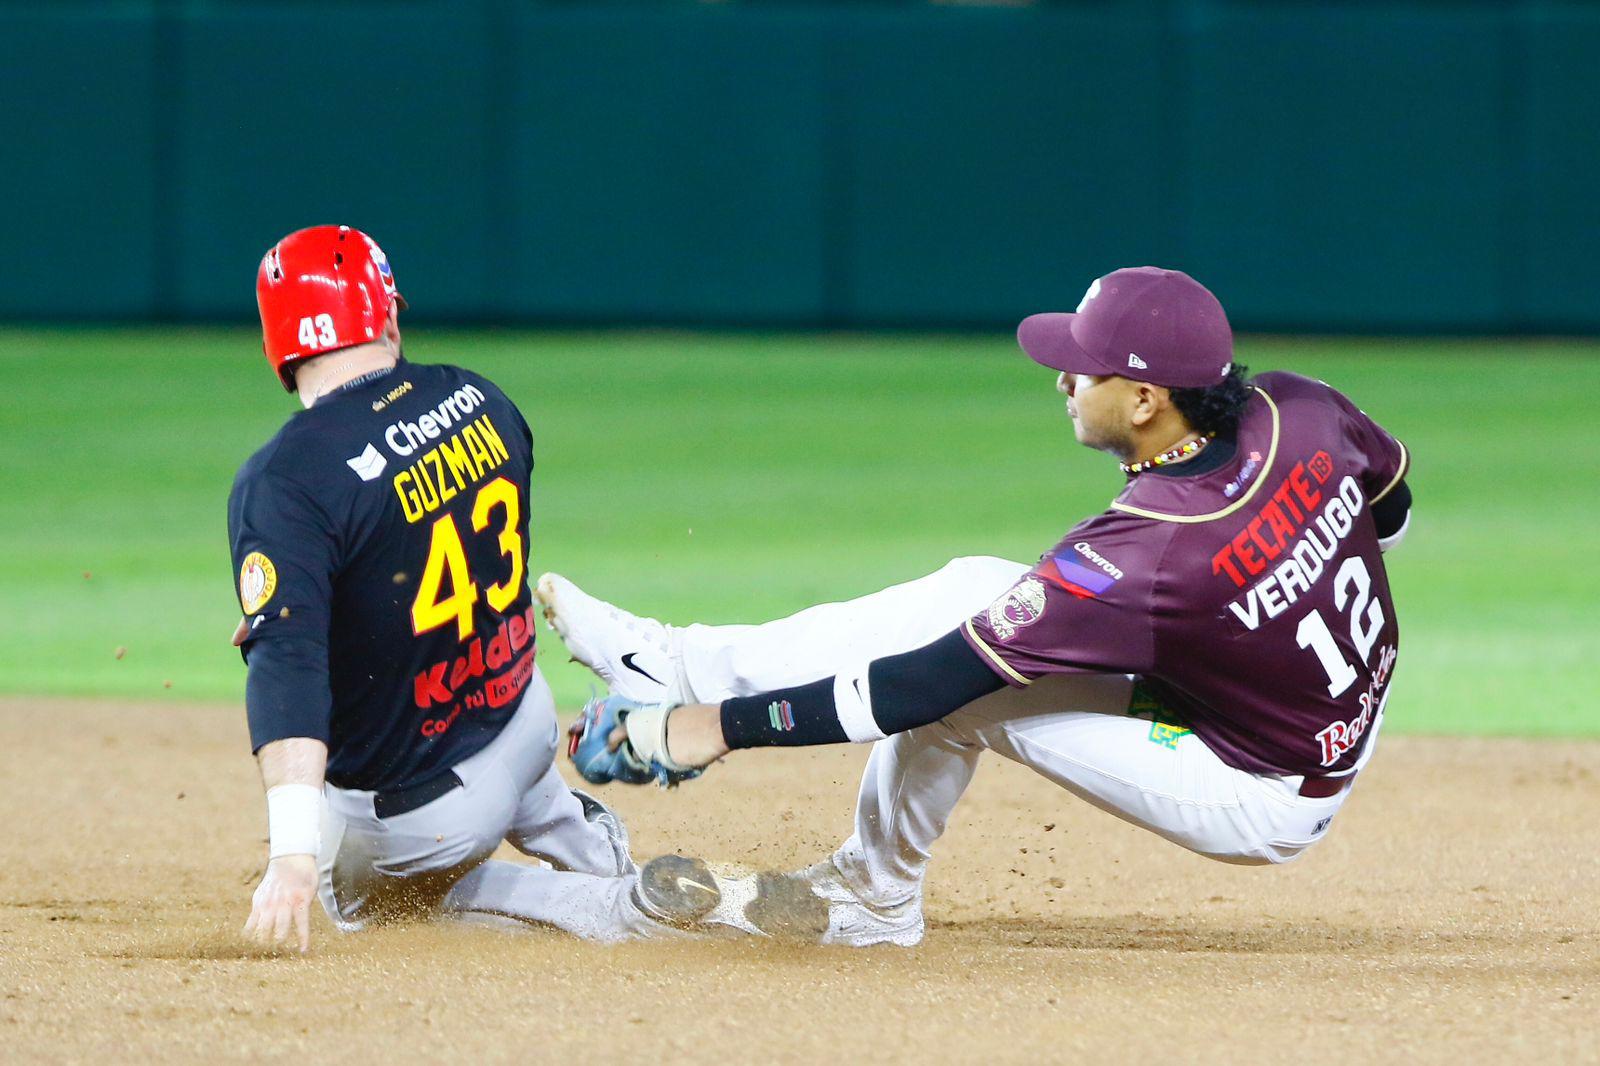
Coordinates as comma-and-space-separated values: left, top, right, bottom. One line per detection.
962, 373, 1408, 776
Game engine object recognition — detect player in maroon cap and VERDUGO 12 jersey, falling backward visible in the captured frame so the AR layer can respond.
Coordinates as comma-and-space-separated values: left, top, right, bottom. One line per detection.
550, 267, 1411, 944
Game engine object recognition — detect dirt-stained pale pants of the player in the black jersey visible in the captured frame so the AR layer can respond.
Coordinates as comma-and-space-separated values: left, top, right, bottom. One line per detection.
318, 669, 675, 941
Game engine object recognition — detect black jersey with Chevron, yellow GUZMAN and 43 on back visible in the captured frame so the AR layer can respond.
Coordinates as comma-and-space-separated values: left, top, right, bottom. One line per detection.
227, 363, 534, 789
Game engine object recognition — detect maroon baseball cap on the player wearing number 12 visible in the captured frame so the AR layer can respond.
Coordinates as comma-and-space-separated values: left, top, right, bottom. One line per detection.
1016, 267, 1234, 389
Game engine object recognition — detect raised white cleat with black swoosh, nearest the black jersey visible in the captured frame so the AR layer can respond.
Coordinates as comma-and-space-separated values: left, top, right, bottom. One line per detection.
533, 573, 693, 704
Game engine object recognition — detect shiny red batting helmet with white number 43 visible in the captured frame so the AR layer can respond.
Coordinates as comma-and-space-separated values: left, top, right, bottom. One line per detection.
256, 226, 405, 392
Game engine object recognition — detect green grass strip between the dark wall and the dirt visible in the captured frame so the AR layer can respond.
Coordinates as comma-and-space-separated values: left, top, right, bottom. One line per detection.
0, 328, 1600, 736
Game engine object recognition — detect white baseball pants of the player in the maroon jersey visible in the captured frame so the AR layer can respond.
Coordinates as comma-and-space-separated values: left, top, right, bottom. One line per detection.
678, 557, 1376, 904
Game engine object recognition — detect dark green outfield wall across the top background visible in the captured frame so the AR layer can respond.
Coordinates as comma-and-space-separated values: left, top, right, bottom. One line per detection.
0, 0, 1600, 331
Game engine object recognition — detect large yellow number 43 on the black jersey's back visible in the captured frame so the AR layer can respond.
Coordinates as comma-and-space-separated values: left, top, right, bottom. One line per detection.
411, 477, 525, 640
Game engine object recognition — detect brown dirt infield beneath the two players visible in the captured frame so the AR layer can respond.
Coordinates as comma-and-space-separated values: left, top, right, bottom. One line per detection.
0, 699, 1600, 1063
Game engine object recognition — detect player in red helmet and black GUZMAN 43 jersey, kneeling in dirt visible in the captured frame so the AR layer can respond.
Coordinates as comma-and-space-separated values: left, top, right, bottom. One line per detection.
227, 226, 700, 951
